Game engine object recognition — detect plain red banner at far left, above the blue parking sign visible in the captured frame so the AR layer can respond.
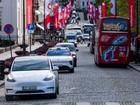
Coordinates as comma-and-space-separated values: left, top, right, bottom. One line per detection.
26, 0, 33, 28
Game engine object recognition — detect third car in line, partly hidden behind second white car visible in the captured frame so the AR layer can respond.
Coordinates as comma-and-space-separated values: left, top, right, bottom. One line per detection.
56, 43, 78, 67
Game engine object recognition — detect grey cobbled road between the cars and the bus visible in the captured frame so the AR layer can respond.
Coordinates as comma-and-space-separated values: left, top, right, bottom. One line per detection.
0, 45, 140, 105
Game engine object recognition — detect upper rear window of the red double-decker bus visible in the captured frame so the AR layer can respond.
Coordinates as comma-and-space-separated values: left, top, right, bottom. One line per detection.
102, 18, 128, 32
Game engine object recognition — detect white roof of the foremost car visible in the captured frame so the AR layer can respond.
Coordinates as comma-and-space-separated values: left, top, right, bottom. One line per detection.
14, 56, 48, 61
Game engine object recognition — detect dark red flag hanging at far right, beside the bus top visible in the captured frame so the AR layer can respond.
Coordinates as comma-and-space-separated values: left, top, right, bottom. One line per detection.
128, 0, 135, 27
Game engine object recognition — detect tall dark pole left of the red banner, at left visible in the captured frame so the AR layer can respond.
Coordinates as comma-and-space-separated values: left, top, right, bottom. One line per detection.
22, 0, 26, 55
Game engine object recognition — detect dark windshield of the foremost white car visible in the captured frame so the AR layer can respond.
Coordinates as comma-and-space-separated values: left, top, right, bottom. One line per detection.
12, 60, 50, 71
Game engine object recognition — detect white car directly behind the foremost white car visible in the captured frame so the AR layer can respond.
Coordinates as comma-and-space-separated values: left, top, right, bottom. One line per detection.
46, 47, 74, 73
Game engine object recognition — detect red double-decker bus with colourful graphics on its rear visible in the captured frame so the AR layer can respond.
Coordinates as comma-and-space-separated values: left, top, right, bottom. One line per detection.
94, 17, 131, 66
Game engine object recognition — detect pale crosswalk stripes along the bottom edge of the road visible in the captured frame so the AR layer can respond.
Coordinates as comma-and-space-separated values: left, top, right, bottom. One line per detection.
47, 102, 140, 105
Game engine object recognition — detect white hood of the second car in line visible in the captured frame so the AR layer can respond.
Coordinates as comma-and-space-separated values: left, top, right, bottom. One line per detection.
49, 56, 72, 62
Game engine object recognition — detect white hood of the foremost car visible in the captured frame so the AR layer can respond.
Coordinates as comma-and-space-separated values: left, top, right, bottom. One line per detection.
9, 70, 53, 81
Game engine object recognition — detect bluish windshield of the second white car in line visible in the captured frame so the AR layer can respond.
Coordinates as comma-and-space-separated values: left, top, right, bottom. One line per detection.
47, 49, 71, 56
